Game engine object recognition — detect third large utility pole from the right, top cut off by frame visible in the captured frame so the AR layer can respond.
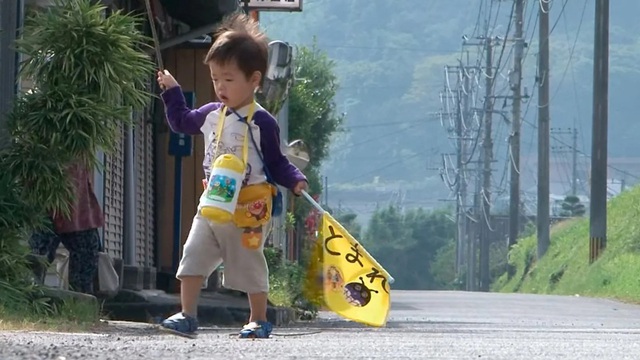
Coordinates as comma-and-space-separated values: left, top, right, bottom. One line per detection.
508, 0, 524, 248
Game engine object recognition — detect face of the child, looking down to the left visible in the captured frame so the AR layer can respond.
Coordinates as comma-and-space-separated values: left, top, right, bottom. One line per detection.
209, 61, 261, 109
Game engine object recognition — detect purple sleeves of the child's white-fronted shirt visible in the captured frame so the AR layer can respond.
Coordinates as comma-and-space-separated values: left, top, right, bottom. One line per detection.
161, 86, 307, 189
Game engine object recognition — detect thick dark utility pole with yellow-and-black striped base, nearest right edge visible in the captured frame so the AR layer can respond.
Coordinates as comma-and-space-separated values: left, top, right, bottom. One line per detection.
589, 0, 609, 263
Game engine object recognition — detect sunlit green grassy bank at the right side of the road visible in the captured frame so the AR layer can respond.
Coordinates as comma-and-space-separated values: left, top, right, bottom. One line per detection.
492, 187, 640, 303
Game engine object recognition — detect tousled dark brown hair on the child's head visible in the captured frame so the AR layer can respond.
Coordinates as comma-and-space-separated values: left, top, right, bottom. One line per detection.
204, 14, 269, 78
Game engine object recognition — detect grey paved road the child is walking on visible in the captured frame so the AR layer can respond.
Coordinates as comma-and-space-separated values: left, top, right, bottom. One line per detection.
0, 291, 640, 360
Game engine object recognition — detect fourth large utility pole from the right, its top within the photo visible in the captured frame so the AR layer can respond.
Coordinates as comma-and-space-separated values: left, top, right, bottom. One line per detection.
478, 38, 494, 291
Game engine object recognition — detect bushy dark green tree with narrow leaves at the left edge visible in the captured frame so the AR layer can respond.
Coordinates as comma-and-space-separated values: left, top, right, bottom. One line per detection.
0, 0, 153, 312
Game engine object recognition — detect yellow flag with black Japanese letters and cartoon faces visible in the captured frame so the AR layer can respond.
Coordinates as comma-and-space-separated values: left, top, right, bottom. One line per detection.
319, 212, 391, 326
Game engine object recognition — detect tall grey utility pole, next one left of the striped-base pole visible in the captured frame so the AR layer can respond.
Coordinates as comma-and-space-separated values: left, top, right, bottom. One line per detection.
537, 1, 550, 259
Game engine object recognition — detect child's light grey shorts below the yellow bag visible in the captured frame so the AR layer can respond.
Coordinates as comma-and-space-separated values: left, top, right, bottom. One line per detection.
176, 214, 271, 294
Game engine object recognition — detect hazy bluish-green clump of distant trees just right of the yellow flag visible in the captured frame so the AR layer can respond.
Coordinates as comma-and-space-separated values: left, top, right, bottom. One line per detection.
363, 206, 455, 289
